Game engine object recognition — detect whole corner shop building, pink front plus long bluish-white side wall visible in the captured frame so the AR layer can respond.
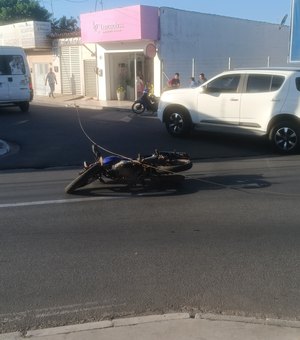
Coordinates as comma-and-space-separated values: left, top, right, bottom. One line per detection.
81, 6, 290, 100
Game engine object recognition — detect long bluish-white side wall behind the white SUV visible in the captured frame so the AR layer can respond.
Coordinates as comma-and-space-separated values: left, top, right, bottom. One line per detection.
158, 8, 290, 85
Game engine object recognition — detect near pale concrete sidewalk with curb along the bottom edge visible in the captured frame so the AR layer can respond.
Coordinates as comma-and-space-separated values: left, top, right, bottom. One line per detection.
0, 313, 300, 340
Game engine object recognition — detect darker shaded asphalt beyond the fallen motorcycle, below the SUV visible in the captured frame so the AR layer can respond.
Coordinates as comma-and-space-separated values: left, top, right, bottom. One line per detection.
0, 104, 271, 170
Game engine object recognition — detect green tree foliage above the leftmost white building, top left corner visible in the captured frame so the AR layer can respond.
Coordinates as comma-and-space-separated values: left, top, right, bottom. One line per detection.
0, 0, 52, 25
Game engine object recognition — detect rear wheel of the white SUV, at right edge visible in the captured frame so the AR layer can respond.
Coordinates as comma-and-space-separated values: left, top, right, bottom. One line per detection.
269, 121, 300, 154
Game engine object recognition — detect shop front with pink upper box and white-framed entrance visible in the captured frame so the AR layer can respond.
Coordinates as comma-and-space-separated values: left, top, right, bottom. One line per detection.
80, 5, 159, 100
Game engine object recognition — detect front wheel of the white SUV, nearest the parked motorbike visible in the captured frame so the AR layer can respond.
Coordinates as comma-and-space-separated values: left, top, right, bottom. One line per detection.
165, 110, 192, 137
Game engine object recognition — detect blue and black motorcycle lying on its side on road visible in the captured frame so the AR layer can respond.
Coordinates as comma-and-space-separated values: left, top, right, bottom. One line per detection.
65, 144, 193, 194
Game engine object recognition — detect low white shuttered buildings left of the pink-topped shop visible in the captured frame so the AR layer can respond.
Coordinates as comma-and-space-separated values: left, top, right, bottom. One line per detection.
0, 21, 97, 97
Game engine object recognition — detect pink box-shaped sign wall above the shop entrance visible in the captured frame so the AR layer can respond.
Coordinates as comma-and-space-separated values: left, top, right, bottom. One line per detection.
80, 5, 159, 43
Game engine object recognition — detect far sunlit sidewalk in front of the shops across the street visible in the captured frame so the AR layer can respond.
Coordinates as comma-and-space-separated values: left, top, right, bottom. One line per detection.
32, 94, 133, 110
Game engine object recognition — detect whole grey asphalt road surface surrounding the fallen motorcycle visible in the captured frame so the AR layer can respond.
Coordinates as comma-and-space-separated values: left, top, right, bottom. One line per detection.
0, 102, 300, 332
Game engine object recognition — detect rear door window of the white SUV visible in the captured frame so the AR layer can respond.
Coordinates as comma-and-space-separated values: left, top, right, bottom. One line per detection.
246, 74, 284, 93
